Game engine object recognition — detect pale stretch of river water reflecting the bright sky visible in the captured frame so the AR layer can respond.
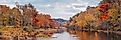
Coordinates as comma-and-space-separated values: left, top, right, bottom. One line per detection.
38, 32, 77, 40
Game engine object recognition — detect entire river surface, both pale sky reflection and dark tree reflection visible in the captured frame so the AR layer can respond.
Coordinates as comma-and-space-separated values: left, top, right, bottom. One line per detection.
2, 32, 121, 40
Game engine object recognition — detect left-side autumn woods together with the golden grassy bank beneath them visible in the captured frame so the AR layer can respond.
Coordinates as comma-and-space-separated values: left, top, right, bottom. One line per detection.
0, 3, 59, 37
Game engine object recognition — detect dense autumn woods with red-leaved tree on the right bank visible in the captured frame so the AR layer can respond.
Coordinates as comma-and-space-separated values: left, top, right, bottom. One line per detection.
66, 0, 121, 31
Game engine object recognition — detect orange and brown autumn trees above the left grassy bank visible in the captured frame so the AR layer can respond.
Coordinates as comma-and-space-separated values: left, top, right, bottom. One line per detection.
0, 4, 58, 28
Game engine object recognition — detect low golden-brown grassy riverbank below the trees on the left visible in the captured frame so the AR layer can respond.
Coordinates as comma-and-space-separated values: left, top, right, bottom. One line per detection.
0, 27, 57, 39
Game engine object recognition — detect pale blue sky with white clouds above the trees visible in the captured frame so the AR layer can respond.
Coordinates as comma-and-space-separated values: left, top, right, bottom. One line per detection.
0, 0, 101, 20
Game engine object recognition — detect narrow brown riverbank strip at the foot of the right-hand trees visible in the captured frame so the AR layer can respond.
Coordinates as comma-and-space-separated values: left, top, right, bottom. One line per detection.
68, 29, 121, 35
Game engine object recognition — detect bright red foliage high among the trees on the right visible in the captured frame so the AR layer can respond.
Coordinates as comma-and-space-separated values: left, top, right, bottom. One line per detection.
97, 2, 111, 20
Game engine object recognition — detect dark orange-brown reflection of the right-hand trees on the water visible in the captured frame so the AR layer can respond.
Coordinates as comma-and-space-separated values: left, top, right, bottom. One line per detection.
77, 32, 121, 40
